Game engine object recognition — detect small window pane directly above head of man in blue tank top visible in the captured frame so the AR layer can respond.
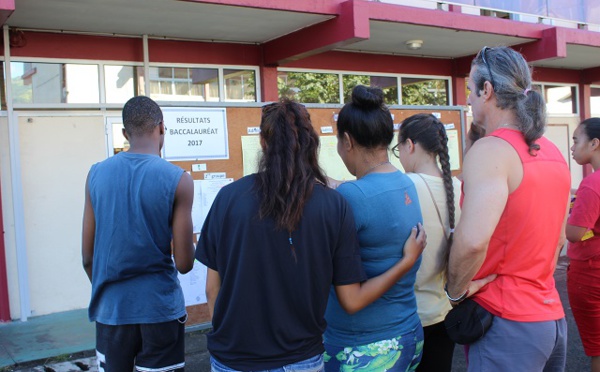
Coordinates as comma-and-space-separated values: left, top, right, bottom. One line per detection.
104, 65, 144, 103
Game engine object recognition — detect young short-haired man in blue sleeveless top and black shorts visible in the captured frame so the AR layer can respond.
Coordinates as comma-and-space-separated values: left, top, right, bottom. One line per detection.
82, 96, 194, 371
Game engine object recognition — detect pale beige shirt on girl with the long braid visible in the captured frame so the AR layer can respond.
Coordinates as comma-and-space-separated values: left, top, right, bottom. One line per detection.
407, 173, 461, 327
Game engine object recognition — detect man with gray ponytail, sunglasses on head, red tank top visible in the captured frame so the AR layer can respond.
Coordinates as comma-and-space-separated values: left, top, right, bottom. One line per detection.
446, 47, 570, 372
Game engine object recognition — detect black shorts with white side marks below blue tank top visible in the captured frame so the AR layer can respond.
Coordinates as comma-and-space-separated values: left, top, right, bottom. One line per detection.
96, 315, 187, 372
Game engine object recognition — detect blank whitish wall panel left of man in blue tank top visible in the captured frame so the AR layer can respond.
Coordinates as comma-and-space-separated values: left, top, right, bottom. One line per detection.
17, 113, 106, 318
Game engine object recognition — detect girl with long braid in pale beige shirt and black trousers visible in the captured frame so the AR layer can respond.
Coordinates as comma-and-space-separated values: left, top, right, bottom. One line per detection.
392, 114, 460, 372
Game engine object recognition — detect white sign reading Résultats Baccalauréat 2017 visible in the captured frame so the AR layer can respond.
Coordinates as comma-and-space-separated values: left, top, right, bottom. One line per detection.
162, 107, 229, 160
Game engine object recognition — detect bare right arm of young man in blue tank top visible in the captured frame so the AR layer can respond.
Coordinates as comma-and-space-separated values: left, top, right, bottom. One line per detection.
173, 172, 194, 274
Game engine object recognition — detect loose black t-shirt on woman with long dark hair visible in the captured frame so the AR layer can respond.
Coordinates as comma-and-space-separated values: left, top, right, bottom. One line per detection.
196, 175, 366, 370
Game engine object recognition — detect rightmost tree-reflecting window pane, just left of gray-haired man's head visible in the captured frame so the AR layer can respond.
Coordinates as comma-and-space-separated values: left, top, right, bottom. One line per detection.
401, 78, 449, 106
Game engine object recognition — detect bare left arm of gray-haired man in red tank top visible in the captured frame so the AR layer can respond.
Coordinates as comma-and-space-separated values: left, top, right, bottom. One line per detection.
448, 137, 520, 298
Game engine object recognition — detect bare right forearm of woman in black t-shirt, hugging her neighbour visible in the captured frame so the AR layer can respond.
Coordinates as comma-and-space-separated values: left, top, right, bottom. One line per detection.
332, 224, 427, 314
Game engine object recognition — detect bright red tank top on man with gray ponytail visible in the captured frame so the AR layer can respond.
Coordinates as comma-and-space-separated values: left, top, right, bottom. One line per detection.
474, 128, 571, 322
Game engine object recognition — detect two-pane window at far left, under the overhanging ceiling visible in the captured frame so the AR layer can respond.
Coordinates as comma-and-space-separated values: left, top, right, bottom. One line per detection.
10, 62, 100, 103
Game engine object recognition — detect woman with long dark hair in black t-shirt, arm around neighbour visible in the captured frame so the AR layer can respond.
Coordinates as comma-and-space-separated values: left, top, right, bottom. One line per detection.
196, 100, 425, 371
